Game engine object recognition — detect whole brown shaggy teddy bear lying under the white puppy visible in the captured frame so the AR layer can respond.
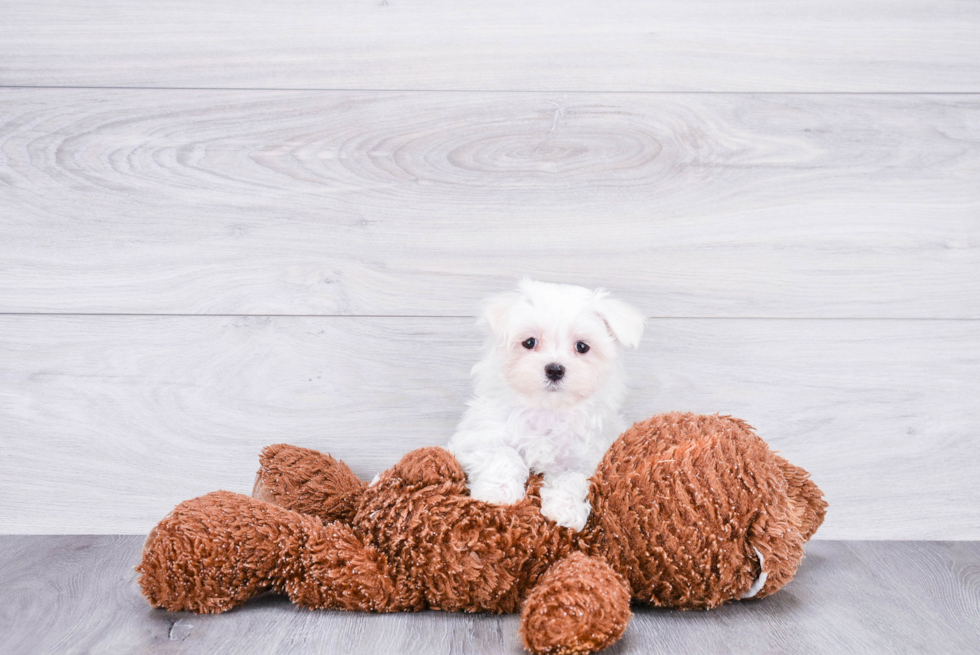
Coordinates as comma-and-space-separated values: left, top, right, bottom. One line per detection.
137, 413, 826, 653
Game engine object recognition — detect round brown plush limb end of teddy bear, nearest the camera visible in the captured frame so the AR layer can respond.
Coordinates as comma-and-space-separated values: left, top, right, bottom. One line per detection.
521, 553, 632, 654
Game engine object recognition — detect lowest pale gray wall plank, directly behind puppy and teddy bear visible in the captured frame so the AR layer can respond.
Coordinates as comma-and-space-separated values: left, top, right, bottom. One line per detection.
0, 316, 980, 539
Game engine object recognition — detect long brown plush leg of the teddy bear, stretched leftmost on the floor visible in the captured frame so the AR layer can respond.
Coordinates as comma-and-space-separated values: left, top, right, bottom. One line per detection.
136, 491, 394, 613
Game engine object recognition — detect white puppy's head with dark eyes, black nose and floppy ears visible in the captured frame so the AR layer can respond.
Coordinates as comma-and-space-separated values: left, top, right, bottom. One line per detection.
474, 278, 644, 409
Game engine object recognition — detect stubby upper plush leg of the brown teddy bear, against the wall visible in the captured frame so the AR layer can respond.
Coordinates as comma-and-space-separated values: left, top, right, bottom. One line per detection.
252, 444, 365, 522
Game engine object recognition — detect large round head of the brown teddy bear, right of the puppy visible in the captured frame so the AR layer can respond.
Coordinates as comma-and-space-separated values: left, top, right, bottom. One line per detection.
582, 413, 826, 608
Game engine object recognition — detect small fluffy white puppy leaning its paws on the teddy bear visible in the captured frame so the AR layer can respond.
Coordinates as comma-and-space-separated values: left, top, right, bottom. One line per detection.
447, 278, 644, 531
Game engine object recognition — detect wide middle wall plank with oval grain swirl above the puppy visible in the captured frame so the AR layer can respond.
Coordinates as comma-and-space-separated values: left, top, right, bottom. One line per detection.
0, 91, 980, 318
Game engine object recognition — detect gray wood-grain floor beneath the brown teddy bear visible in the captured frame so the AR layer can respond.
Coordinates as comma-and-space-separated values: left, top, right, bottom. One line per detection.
0, 535, 980, 655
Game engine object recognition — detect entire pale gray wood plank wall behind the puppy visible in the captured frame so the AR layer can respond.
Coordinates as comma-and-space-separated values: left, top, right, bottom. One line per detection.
0, 0, 980, 539
